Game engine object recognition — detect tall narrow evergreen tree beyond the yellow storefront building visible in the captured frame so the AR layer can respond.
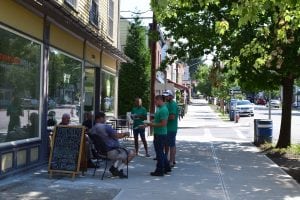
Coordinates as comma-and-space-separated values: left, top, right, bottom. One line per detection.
118, 17, 150, 115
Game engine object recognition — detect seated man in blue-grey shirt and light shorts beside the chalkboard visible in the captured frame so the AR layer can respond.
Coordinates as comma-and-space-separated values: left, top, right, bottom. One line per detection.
91, 112, 135, 178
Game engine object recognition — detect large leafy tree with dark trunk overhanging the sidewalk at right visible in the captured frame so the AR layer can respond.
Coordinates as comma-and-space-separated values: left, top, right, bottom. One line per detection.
152, 0, 300, 147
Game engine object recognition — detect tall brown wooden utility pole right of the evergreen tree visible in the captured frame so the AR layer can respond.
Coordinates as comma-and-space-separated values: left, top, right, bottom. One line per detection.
150, 13, 157, 114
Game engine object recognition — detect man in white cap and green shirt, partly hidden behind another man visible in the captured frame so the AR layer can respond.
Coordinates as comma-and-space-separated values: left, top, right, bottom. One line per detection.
163, 90, 178, 167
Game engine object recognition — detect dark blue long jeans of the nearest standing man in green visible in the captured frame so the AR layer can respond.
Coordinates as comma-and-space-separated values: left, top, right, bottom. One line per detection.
153, 134, 170, 173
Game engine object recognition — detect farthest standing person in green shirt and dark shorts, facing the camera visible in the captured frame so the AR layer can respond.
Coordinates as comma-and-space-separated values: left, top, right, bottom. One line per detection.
131, 98, 150, 157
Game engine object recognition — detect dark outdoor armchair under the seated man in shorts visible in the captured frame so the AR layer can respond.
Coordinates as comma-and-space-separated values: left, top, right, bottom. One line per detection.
90, 134, 128, 180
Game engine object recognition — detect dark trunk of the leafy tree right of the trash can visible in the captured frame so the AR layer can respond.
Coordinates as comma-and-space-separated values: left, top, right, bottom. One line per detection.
276, 77, 294, 148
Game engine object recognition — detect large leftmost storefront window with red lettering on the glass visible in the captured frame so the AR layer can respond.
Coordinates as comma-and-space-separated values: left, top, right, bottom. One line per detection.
0, 27, 41, 143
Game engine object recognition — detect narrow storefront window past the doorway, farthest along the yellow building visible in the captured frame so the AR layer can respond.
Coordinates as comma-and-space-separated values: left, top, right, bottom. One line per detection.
101, 71, 115, 116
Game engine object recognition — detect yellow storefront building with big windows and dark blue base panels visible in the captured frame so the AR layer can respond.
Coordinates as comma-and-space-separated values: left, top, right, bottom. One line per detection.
0, 0, 127, 179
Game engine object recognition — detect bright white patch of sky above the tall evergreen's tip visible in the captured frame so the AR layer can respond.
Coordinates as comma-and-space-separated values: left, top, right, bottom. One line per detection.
120, 0, 152, 26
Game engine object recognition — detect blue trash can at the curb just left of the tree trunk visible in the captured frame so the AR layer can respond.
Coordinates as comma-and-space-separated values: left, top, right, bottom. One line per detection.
254, 119, 273, 146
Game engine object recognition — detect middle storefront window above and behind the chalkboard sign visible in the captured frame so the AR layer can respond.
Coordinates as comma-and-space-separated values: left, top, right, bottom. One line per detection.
47, 48, 82, 127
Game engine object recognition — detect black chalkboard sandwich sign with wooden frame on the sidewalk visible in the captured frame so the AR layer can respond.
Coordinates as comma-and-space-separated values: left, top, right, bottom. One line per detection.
48, 125, 85, 179
